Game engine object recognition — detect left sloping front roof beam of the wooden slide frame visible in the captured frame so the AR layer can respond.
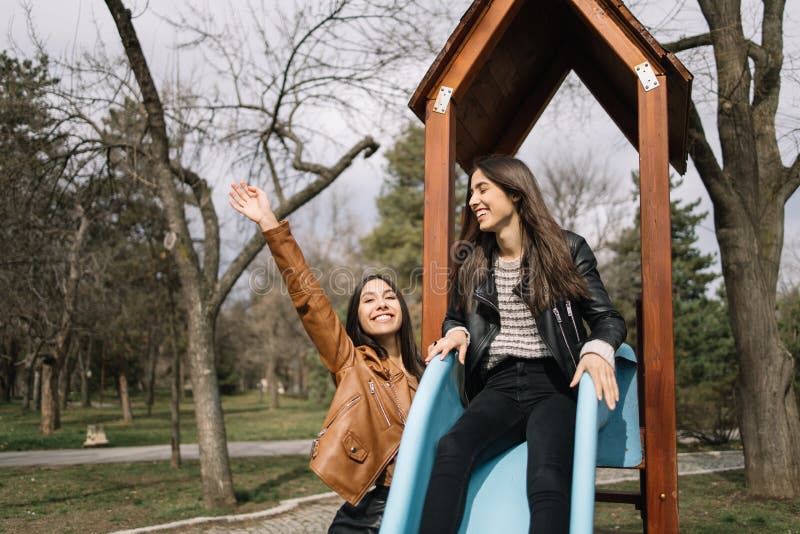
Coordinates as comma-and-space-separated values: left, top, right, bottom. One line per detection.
428, 0, 525, 102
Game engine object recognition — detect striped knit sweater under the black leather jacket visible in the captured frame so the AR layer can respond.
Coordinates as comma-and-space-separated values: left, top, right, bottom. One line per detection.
483, 257, 552, 370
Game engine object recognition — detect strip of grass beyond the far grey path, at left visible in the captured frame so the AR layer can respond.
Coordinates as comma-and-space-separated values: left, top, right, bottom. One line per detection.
0, 392, 327, 451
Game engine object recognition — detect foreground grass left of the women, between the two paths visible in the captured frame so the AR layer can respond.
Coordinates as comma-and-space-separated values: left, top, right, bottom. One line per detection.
0, 456, 330, 533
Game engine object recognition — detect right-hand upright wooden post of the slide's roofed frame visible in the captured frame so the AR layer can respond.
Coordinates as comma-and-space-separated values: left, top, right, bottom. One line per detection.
638, 76, 678, 533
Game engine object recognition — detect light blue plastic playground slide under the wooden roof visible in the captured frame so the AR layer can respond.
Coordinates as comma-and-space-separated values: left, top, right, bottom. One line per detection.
381, 345, 642, 534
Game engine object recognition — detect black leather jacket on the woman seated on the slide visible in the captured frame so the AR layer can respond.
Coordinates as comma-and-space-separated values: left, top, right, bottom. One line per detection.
442, 231, 627, 401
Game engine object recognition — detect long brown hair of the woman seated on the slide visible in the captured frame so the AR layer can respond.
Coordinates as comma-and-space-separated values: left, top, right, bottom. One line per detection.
454, 156, 589, 314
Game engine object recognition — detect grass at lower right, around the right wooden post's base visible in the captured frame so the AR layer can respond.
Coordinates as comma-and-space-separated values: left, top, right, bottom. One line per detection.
595, 471, 800, 534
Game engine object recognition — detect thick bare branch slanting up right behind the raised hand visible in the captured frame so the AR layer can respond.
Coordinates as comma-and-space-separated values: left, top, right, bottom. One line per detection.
209, 136, 379, 316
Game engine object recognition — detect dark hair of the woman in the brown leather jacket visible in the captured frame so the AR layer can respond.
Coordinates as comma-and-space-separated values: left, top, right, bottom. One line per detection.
345, 274, 424, 379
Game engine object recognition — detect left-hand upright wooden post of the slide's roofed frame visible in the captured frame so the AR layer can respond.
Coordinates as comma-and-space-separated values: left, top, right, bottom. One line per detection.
422, 100, 456, 353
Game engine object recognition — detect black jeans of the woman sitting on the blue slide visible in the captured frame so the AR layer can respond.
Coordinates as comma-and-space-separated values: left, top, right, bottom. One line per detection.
420, 358, 575, 534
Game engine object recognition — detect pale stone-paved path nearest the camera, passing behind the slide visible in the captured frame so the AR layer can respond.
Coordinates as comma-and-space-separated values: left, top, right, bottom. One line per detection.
100, 451, 744, 534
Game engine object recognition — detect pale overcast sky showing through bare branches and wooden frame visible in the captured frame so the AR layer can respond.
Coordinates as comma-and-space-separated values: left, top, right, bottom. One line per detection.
0, 0, 800, 294
